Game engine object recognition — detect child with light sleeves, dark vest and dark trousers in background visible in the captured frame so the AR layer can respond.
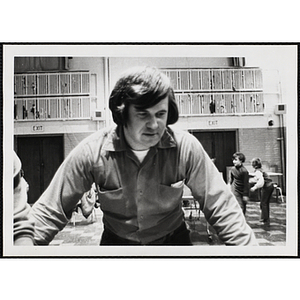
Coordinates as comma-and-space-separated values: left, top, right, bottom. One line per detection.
250, 158, 274, 224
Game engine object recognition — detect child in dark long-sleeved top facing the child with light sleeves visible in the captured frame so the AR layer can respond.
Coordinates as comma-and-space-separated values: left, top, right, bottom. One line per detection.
229, 152, 249, 215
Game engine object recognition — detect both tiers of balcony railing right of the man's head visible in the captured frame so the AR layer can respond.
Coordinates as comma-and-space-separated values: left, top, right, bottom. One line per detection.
163, 68, 264, 116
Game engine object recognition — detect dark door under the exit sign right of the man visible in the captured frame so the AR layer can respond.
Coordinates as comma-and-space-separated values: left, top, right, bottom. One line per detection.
191, 131, 236, 181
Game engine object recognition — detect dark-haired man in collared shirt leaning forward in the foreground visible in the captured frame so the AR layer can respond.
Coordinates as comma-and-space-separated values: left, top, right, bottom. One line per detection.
32, 67, 257, 245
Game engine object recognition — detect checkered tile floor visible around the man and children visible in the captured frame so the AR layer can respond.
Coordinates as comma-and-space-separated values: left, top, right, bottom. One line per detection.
50, 201, 286, 246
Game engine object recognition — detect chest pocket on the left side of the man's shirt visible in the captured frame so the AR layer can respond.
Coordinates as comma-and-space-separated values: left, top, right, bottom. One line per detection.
99, 188, 125, 215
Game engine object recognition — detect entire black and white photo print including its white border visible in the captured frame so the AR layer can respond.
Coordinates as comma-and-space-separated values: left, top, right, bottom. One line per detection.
3, 43, 298, 257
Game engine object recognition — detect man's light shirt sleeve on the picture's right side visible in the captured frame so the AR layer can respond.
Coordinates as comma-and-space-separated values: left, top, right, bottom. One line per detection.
182, 136, 258, 245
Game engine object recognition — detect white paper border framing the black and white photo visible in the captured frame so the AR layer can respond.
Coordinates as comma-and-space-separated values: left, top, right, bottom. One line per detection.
3, 43, 298, 257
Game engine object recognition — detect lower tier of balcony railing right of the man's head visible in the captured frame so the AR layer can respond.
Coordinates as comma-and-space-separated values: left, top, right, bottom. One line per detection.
175, 92, 264, 116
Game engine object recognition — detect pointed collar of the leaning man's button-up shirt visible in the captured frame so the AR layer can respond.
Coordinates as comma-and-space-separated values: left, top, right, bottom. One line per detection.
102, 126, 177, 152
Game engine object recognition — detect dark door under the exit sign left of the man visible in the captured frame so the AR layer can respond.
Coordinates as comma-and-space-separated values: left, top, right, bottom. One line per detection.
17, 136, 63, 203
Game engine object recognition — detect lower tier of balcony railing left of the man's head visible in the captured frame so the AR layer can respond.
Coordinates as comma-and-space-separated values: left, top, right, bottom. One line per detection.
14, 96, 93, 121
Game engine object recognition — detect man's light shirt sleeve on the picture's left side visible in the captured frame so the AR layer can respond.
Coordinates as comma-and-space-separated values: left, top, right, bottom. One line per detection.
30, 144, 93, 245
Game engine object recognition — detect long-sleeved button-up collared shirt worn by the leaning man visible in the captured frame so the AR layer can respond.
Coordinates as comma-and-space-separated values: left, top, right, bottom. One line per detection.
32, 127, 256, 245
